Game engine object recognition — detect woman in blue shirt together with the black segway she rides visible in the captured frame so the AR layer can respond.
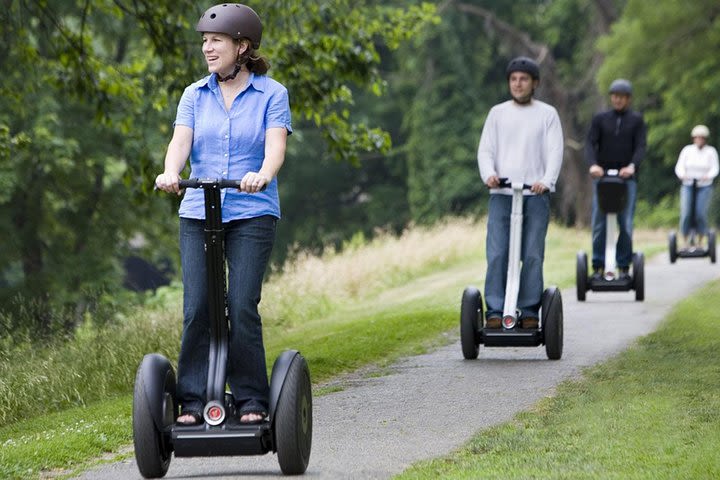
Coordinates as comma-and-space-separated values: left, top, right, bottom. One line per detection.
139, 3, 312, 478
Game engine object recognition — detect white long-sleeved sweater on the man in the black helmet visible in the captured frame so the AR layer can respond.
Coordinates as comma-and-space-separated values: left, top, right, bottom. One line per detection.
478, 99, 564, 195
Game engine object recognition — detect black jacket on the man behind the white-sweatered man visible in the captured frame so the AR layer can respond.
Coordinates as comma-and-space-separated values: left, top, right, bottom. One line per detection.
585, 110, 647, 175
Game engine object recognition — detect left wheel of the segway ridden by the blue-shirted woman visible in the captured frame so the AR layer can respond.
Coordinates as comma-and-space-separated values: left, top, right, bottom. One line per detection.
133, 354, 177, 478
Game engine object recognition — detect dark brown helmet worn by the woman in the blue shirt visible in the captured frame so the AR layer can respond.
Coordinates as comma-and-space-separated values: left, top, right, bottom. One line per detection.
195, 3, 262, 50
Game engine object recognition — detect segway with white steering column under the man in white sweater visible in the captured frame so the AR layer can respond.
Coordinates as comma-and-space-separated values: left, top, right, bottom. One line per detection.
460, 179, 563, 360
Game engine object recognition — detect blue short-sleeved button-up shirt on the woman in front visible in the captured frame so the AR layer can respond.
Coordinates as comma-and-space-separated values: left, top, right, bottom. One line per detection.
175, 73, 292, 222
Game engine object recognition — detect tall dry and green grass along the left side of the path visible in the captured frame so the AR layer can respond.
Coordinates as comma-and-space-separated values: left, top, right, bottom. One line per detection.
0, 219, 664, 478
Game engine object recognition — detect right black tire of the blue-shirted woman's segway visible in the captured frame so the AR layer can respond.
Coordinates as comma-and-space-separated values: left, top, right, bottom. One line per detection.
275, 354, 312, 475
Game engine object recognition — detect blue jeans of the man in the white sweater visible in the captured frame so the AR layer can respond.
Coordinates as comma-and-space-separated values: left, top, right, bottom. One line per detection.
485, 194, 550, 318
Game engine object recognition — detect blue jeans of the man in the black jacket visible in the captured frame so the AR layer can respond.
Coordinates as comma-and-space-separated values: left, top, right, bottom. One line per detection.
592, 180, 637, 269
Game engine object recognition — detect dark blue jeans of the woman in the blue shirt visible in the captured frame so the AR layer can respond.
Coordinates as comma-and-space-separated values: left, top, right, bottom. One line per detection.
177, 216, 277, 412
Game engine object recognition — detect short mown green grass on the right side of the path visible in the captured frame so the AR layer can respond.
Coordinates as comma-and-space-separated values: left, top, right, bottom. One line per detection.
396, 282, 720, 480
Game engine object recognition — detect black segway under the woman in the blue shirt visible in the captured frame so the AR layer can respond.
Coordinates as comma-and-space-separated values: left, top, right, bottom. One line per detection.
133, 179, 312, 478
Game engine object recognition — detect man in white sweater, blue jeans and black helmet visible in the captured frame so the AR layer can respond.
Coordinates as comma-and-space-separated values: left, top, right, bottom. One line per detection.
478, 57, 563, 328
